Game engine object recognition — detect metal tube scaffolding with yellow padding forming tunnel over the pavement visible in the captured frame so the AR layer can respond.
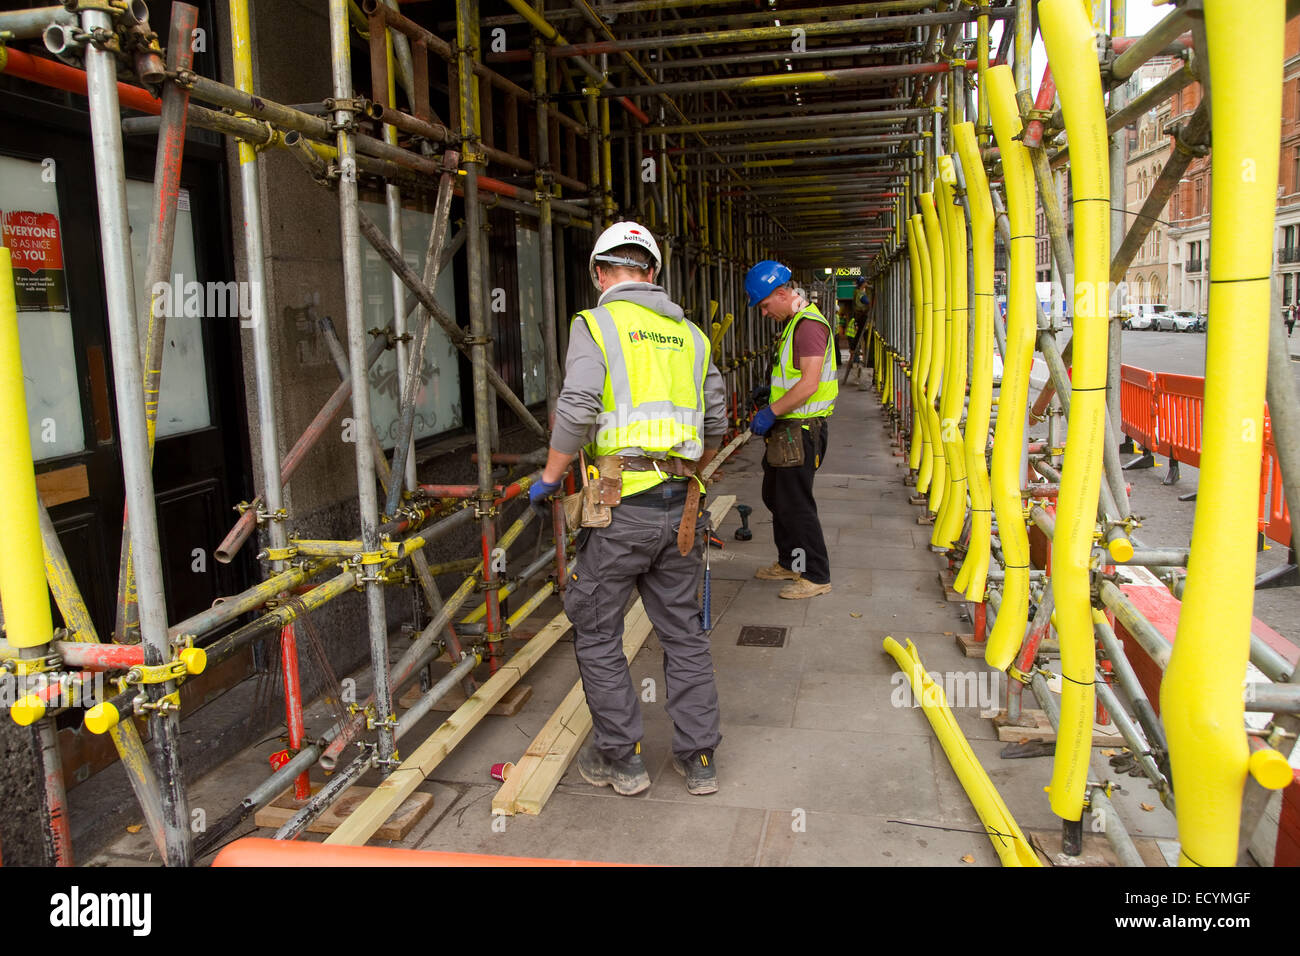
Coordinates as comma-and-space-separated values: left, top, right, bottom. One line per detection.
0, 0, 1300, 865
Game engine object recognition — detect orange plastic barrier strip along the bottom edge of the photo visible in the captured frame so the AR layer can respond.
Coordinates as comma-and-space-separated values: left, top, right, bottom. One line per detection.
212, 836, 634, 866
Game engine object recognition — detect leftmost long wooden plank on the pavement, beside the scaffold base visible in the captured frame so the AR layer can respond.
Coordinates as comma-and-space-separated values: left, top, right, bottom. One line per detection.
325, 613, 572, 847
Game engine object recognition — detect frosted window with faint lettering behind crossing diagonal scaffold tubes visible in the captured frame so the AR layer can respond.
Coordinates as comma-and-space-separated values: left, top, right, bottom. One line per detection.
361, 202, 462, 449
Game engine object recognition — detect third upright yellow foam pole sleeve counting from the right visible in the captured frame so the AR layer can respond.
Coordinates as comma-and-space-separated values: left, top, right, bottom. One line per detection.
984, 65, 1037, 670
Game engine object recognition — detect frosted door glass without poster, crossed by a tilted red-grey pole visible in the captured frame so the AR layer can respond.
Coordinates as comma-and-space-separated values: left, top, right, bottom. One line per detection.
126, 179, 211, 438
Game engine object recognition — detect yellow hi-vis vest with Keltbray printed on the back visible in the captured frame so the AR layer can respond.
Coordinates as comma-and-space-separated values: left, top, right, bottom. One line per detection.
579, 300, 709, 496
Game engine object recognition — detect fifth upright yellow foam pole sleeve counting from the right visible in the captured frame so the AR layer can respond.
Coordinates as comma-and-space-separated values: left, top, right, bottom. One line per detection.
930, 167, 969, 548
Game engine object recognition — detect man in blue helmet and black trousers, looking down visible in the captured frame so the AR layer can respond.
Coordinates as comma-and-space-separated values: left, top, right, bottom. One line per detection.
745, 260, 840, 600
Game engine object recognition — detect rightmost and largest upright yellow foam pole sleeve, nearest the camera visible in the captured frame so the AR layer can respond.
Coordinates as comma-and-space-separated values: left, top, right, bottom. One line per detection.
1164, 0, 1286, 866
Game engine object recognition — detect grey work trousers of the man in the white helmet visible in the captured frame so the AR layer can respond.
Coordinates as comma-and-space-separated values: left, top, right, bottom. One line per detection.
564, 489, 722, 760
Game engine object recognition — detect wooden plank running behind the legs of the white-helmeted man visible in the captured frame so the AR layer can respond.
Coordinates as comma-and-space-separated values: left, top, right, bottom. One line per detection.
491, 496, 744, 816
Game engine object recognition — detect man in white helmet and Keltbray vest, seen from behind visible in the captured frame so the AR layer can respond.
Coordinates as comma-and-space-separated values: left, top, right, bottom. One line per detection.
529, 222, 727, 796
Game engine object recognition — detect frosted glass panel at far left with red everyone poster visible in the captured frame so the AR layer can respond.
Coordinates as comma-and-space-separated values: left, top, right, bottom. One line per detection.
0, 156, 86, 462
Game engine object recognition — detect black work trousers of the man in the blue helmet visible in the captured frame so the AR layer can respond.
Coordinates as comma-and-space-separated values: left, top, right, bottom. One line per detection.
763, 419, 831, 584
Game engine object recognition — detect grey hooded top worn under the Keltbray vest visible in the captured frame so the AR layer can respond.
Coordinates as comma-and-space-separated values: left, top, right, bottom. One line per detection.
551, 282, 727, 455
